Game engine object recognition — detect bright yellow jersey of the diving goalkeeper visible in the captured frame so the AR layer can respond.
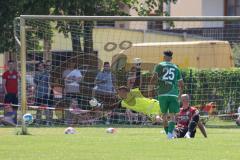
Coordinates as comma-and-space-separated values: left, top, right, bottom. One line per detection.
121, 88, 161, 117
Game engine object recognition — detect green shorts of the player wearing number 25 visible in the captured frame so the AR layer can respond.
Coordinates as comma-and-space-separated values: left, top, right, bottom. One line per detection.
158, 96, 180, 113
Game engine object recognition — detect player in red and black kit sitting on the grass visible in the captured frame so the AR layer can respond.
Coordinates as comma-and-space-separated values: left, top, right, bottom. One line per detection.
175, 94, 207, 138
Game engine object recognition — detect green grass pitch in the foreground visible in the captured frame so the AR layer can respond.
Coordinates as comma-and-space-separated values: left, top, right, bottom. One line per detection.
0, 126, 240, 160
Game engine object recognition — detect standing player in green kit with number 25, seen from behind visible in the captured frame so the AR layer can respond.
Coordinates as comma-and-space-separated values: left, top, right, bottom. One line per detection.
149, 51, 184, 139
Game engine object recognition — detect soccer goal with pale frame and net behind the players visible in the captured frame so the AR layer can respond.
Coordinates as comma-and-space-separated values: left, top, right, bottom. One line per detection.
12, 15, 240, 134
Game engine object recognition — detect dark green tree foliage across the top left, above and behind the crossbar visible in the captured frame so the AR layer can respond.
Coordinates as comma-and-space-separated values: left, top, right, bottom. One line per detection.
0, 0, 176, 53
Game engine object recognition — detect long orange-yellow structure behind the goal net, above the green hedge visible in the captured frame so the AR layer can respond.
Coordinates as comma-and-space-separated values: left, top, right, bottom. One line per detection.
112, 41, 234, 70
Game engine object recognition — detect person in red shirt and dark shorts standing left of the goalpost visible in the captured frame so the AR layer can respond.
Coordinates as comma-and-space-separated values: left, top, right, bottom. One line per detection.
2, 60, 19, 124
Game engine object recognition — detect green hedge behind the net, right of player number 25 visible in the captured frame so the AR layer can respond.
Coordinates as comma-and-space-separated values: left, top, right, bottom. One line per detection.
182, 68, 240, 110
